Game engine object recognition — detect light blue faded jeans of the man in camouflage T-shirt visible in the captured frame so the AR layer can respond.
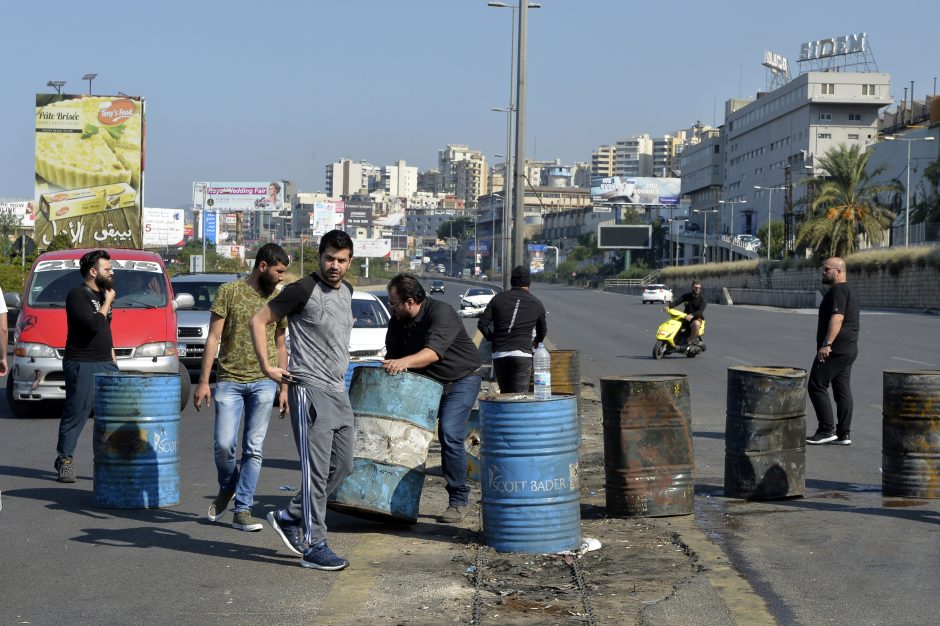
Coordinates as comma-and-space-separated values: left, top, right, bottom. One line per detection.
212, 378, 277, 513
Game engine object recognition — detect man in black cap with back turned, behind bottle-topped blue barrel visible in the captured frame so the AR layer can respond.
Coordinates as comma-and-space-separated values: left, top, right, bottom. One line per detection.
477, 265, 547, 393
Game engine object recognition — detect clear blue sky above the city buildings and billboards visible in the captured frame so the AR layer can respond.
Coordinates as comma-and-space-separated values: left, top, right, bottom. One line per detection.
0, 0, 940, 207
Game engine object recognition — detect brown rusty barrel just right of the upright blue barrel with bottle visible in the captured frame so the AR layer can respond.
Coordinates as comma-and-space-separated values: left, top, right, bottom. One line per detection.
601, 374, 695, 517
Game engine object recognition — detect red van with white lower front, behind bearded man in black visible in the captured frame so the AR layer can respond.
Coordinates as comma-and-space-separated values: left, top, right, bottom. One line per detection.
7, 249, 193, 417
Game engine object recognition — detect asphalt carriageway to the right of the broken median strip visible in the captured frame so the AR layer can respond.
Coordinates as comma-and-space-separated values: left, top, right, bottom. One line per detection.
520, 285, 940, 624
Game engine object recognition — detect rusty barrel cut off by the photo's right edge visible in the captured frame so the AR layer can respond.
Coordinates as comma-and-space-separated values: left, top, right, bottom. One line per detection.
881, 371, 940, 498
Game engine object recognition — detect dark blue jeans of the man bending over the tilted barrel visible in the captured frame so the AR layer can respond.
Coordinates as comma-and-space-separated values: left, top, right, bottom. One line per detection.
437, 375, 483, 506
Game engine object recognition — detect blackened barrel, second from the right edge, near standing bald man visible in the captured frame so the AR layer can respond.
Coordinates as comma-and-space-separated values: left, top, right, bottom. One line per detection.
725, 366, 806, 500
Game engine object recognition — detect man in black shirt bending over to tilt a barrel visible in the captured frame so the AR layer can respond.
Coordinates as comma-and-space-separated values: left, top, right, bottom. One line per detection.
382, 274, 483, 524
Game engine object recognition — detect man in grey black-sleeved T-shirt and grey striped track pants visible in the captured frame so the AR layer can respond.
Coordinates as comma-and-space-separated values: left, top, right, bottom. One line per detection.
251, 230, 356, 571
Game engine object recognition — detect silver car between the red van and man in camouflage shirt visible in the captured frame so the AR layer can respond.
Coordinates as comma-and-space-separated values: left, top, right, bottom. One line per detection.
170, 273, 240, 377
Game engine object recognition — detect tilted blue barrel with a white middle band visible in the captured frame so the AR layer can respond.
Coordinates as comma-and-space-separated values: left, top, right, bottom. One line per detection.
328, 367, 444, 524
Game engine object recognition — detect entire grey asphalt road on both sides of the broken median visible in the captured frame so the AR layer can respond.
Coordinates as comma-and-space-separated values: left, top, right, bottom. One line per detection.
0, 282, 940, 626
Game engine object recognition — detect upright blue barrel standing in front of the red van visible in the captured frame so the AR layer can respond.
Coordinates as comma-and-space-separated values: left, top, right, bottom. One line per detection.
92, 373, 180, 509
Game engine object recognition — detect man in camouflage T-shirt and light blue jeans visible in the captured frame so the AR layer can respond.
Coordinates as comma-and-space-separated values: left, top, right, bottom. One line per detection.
193, 243, 290, 531
